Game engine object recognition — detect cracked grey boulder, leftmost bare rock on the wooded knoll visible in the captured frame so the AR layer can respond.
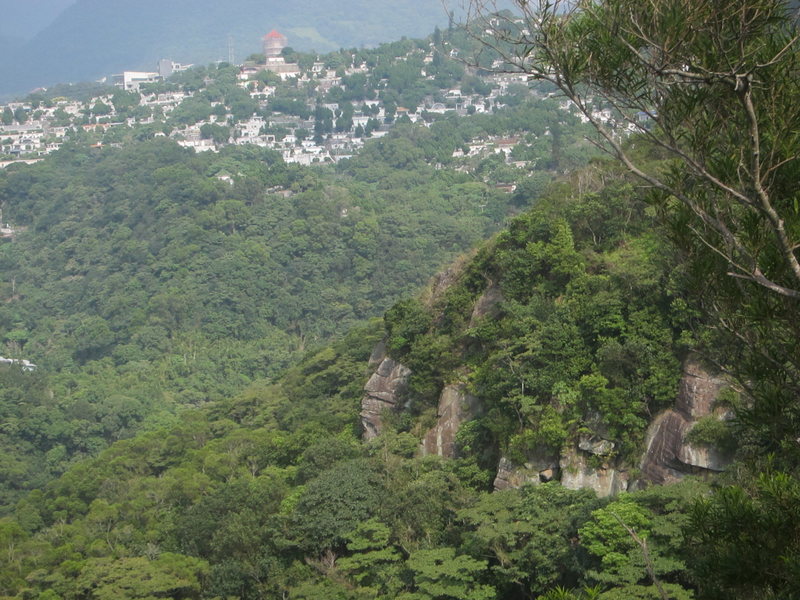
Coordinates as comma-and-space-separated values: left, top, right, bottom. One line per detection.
361, 344, 411, 440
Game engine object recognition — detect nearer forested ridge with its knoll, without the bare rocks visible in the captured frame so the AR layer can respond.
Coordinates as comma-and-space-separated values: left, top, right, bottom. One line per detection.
2, 159, 736, 600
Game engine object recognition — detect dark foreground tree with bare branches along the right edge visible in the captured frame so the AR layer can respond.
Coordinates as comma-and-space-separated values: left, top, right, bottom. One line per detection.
471, 0, 800, 598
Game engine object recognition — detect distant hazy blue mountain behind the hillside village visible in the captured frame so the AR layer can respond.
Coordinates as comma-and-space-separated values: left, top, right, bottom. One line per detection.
0, 0, 454, 94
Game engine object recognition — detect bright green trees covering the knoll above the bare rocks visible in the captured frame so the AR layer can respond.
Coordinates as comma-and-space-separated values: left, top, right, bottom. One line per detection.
386, 164, 691, 476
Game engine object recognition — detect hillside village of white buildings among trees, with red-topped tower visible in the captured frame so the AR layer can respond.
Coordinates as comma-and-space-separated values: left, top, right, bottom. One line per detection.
0, 25, 624, 171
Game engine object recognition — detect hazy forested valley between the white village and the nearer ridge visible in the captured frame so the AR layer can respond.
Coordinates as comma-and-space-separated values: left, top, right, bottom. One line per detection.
0, 96, 589, 506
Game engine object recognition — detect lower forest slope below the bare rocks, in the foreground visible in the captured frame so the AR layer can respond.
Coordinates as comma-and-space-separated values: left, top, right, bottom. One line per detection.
0, 314, 705, 598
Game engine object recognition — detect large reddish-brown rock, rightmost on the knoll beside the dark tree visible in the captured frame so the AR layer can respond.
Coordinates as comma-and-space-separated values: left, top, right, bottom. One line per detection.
640, 359, 730, 484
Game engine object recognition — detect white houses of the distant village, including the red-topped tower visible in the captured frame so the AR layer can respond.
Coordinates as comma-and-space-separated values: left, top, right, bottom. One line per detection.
0, 30, 540, 167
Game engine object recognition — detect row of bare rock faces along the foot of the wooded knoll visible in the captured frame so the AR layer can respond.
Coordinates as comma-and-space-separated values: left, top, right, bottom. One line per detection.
361, 342, 729, 496
